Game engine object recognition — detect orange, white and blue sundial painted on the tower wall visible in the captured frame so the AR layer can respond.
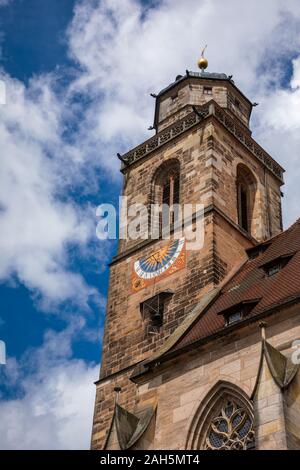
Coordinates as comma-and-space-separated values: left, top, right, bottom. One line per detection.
132, 238, 185, 291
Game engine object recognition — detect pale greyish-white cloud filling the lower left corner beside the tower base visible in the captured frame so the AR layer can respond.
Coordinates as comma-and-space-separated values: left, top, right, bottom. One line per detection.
0, 360, 99, 450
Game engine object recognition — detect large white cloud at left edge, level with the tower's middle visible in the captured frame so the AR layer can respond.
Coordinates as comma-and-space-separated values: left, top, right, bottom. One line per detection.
0, 75, 98, 303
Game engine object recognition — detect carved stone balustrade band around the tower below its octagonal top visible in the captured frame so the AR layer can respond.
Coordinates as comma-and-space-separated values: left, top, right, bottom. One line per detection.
120, 100, 284, 181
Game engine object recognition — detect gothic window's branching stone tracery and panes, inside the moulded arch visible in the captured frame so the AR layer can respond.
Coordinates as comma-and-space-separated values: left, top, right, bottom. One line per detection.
204, 397, 255, 450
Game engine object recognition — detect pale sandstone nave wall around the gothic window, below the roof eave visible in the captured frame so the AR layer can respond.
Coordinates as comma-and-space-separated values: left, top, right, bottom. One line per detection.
135, 309, 300, 449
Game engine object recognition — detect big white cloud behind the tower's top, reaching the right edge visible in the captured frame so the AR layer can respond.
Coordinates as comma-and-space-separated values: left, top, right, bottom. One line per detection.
68, 0, 300, 223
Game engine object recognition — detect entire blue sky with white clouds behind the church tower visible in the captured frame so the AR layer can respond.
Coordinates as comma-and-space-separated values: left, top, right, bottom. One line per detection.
0, 0, 300, 449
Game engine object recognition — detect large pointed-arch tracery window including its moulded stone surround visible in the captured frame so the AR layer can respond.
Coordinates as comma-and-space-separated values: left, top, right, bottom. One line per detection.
186, 381, 255, 450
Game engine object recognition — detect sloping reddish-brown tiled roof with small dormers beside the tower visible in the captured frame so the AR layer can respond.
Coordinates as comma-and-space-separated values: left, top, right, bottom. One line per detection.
172, 219, 300, 350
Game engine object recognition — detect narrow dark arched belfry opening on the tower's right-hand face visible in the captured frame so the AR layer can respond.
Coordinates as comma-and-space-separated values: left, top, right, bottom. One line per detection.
236, 164, 256, 234
